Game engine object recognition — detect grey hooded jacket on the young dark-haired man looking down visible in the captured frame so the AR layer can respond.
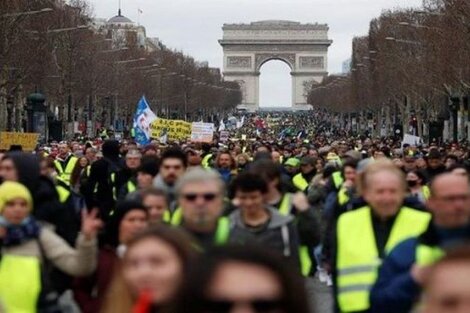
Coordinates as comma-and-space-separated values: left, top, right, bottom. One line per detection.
229, 207, 300, 264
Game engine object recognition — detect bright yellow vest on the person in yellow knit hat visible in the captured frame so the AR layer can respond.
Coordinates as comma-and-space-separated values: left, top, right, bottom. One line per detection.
0, 254, 41, 313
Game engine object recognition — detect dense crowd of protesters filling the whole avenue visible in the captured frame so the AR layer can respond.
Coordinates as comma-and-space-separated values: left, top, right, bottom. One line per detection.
0, 112, 470, 313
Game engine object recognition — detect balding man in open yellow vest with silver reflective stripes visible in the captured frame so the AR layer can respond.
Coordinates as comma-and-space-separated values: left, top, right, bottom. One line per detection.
333, 160, 431, 312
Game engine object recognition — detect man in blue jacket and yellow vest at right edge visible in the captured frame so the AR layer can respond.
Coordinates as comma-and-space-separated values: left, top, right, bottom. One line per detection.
371, 173, 470, 313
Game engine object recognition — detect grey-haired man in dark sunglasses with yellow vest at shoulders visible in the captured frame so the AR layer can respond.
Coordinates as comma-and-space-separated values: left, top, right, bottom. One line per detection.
170, 168, 230, 250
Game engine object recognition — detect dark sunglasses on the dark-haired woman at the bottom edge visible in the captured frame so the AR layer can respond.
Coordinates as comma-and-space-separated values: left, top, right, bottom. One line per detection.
204, 299, 284, 313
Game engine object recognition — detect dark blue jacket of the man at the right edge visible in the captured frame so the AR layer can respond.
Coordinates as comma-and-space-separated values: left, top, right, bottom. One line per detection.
370, 223, 470, 313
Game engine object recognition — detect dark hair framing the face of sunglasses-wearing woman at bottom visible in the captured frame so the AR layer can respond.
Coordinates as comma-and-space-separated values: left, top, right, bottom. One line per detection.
174, 245, 312, 313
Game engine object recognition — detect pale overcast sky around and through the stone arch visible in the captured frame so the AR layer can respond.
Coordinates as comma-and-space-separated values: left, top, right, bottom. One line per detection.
88, 0, 422, 106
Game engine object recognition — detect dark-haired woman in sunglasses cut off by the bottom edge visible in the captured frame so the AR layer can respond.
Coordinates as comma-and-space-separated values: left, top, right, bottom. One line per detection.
175, 246, 312, 313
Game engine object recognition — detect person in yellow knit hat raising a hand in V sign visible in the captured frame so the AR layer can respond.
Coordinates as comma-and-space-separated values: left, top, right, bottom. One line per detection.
0, 182, 101, 312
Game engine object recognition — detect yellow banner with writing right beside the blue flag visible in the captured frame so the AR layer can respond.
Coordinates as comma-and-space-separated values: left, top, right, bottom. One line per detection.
150, 118, 191, 140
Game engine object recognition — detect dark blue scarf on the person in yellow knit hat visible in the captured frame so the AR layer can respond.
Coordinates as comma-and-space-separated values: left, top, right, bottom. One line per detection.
0, 216, 41, 247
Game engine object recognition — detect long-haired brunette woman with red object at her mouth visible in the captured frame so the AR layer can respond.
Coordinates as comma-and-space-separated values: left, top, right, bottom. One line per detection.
102, 225, 195, 313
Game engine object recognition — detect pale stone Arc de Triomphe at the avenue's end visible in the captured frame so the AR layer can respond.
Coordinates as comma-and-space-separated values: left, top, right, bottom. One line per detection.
219, 21, 332, 111
